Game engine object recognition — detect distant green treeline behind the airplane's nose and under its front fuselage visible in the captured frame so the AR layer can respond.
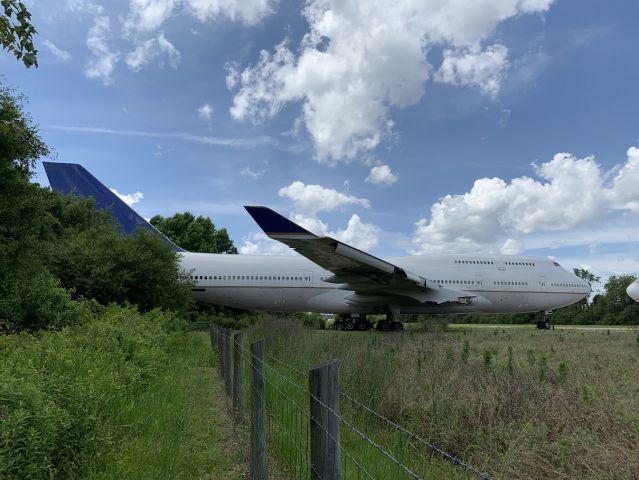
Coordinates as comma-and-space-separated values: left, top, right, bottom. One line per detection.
419, 271, 639, 325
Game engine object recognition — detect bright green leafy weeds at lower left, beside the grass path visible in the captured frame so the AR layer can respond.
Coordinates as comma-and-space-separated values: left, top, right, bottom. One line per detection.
0, 302, 181, 479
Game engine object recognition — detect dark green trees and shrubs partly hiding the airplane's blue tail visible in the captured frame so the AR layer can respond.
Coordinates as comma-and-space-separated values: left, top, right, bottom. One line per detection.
0, 82, 192, 331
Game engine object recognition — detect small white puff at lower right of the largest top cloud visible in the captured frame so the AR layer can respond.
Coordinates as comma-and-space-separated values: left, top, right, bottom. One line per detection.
435, 44, 509, 97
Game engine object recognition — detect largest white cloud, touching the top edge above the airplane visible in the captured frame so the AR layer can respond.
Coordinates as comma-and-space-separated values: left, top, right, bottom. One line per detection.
227, 0, 553, 163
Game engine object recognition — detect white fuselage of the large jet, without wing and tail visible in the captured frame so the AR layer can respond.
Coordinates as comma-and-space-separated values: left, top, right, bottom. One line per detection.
180, 252, 590, 314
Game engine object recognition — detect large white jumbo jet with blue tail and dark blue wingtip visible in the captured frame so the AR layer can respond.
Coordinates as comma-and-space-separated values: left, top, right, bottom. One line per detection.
43, 162, 590, 331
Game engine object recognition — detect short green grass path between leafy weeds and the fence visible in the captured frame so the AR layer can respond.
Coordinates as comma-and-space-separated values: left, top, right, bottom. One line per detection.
87, 332, 248, 480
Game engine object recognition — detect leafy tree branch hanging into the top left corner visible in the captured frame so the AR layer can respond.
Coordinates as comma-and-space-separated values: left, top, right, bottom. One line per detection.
0, 0, 38, 68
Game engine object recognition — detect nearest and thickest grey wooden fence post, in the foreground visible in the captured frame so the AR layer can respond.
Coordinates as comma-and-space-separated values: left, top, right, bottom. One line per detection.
308, 360, 340, 480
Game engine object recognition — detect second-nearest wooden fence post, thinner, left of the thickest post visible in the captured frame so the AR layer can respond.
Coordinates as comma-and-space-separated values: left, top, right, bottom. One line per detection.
250, 339, 268, 480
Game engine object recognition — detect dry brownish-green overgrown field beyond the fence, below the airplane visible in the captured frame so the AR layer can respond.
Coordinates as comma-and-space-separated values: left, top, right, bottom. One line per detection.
247, 319, 639, 479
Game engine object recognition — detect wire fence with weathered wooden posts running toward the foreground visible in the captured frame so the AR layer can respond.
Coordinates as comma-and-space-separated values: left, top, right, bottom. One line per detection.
210, 324, 490, 480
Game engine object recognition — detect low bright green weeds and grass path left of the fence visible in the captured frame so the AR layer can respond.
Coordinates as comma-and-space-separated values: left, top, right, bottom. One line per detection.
0, 306, 245, 479
